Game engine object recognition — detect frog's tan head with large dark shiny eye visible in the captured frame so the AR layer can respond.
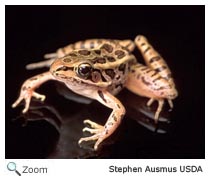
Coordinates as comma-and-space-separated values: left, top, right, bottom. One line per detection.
50, 53, 109, 87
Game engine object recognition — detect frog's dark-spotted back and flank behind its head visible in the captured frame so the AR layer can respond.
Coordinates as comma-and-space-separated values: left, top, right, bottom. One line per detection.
93, 42, 136, 95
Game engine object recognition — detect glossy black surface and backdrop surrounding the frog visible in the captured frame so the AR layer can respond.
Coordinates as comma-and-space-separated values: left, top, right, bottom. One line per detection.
5, 6, 205, 159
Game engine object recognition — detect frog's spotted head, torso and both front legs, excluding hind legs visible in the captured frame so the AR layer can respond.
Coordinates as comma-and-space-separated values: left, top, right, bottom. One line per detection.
13, 41, 136, 150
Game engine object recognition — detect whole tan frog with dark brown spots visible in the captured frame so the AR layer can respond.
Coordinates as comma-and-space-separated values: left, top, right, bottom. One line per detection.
12, 35, 178, 151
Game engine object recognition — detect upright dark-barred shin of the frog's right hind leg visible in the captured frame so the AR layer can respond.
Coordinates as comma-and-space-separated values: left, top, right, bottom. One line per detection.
135, 35, 175, 86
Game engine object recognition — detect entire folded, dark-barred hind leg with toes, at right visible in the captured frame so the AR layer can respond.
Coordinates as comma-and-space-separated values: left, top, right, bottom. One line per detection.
126, 35, 178, 122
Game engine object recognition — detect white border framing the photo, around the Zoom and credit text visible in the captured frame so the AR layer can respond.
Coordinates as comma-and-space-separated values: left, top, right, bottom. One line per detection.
0, 0, 210, 179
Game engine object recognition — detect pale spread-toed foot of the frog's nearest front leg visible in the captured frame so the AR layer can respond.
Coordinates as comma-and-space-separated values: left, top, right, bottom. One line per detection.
78, 120, 106, 150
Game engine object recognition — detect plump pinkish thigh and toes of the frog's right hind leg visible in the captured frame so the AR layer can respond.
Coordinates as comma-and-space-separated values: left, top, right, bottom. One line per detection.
125, 64, 168, 122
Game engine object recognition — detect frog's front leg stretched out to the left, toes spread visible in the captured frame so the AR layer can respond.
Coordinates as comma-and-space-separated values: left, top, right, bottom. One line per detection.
12, 72, 54, 113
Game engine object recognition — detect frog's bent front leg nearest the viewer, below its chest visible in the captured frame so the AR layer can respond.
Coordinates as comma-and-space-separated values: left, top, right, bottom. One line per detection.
78, 90, 125, 150
